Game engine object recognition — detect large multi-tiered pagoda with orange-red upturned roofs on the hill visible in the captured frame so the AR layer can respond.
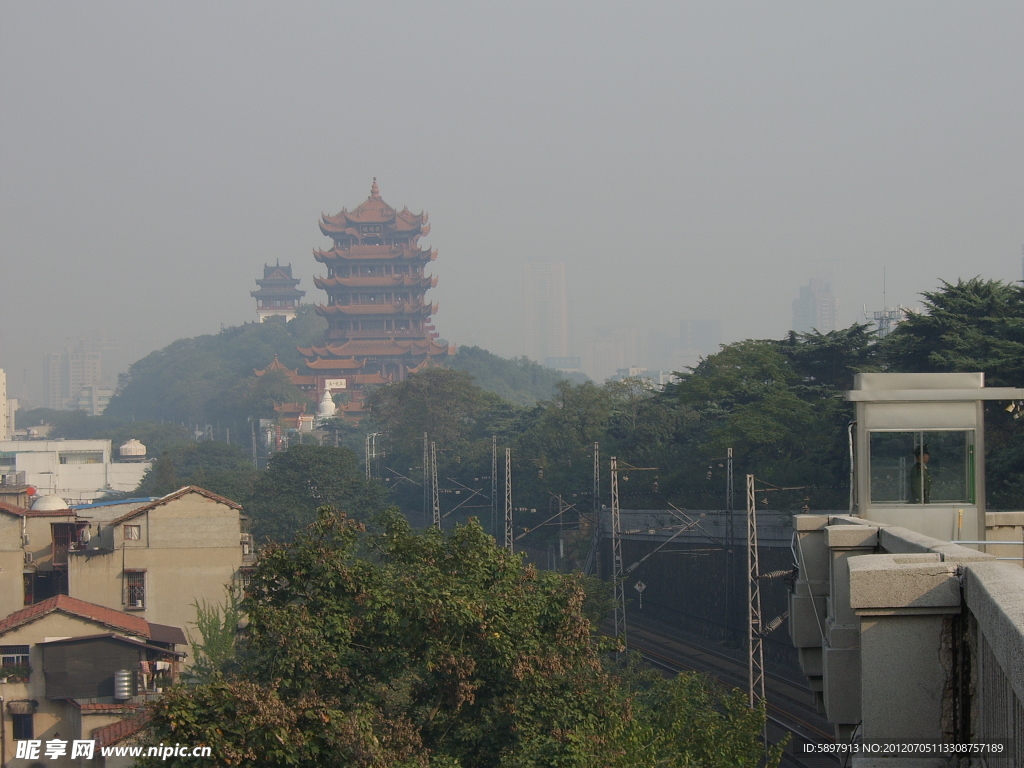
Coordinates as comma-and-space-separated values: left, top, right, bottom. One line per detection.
290, 178, 455, 411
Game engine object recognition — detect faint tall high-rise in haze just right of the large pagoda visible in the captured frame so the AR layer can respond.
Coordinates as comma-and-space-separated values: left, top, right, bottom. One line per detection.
522, 262, 569, 364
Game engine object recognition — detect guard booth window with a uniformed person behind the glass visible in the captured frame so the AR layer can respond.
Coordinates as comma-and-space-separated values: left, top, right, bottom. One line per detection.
868, 429, 975, 504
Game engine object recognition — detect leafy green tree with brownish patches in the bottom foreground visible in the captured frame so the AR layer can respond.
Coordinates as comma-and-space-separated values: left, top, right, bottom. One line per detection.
140, 509, 778, 768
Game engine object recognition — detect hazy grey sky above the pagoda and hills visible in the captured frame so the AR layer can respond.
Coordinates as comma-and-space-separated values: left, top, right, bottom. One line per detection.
0, 0, 1024, 399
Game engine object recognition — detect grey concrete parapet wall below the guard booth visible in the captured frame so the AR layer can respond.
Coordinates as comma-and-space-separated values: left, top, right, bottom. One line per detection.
790, 513, 1024, 753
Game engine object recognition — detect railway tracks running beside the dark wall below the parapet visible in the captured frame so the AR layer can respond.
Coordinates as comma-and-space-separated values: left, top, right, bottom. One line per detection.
614, 623, 843, 768
